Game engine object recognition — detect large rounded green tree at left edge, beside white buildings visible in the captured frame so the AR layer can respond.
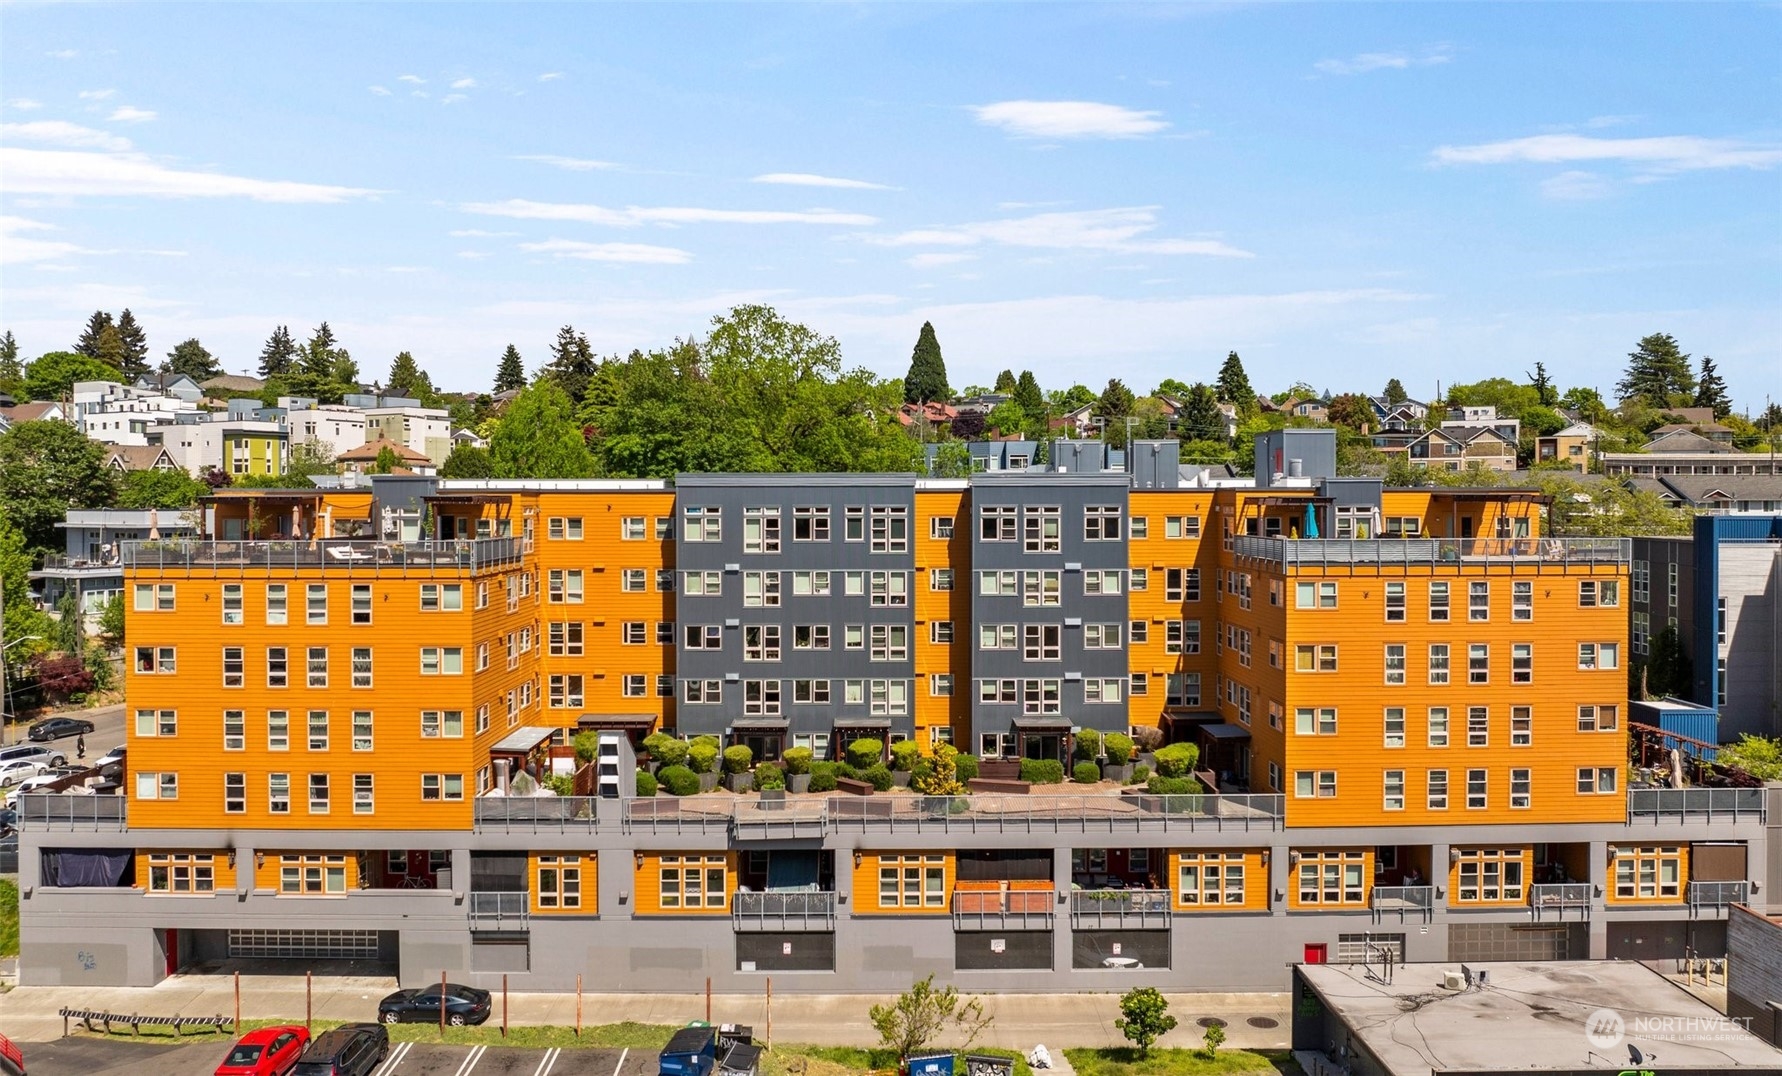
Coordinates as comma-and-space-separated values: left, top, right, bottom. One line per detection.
0, 420, 118, 549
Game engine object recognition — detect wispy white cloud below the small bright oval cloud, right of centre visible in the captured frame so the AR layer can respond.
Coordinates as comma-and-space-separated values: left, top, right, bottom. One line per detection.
866, 205, 1255, 258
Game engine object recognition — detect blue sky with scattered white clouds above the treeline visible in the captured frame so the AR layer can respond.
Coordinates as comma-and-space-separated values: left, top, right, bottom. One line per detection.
0, 4, 1782, 410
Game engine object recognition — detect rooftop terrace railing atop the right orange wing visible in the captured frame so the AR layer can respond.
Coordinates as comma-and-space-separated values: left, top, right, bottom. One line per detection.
1233, 534, 1634, 572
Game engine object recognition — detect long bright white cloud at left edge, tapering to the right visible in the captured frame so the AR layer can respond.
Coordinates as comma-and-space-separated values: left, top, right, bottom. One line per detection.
0, 146, 380, 203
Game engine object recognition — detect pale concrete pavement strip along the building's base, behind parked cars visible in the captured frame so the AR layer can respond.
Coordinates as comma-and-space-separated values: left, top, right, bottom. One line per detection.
0, 974, 1290, 1051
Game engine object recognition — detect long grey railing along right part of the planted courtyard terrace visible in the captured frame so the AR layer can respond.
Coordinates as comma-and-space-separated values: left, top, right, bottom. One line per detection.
829, 795, 1285, 834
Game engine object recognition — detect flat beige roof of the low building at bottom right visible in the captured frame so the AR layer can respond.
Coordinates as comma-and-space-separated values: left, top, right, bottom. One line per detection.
1297, 960, 1782, 1076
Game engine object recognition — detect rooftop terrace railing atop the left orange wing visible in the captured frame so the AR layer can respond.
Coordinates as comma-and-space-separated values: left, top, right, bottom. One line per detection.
119, 538, 520, 574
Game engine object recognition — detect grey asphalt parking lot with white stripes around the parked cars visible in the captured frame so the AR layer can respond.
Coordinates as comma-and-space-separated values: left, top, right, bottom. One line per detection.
25, 1037, 656, 1076
